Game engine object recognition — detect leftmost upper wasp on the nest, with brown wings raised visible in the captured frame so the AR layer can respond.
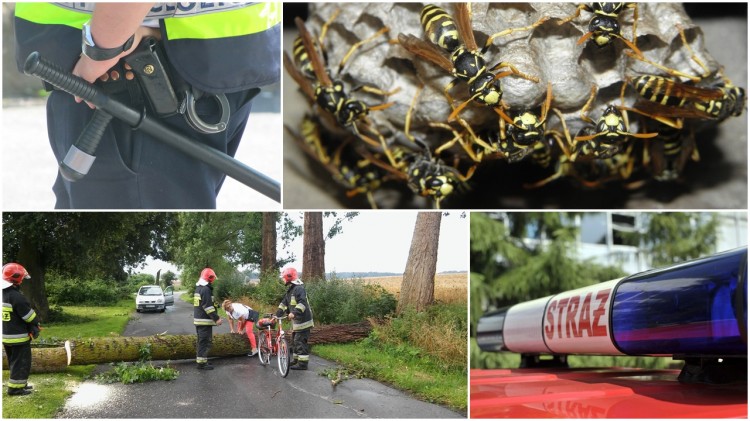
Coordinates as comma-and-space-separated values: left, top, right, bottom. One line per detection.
284, 18, 397, 144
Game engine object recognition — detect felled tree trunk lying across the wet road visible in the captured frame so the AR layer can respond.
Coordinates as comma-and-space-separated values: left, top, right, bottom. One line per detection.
3, 322, 372, 373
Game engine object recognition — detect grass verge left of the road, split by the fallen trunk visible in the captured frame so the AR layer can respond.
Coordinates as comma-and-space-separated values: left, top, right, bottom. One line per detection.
3, 300, 135, 419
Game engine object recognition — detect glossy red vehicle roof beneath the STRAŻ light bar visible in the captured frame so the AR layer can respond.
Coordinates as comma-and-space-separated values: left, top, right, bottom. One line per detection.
469, 368, 748, 419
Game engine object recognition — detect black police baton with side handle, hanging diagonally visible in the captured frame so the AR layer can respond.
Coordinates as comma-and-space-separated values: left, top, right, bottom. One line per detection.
24, 52, 281, 203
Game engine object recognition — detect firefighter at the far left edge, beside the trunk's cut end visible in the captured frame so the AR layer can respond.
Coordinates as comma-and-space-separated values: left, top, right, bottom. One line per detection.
2, 263, 41, 396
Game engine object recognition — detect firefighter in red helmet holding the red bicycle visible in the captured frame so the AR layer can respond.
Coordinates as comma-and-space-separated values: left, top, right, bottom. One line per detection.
276, 268, 313, 370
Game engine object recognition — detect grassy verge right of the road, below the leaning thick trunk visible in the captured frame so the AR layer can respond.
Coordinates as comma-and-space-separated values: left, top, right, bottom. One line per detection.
312, 303, 468, 412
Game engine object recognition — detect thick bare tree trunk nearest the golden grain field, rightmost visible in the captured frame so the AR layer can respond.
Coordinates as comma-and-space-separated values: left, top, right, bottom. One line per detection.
396, 212, 442, 313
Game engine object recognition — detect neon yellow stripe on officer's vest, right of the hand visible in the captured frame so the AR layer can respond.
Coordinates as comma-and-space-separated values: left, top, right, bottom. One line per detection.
164, 2, 281, 40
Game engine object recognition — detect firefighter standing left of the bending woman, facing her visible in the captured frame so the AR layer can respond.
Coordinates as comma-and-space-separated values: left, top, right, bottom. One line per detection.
193, 268, 221, 370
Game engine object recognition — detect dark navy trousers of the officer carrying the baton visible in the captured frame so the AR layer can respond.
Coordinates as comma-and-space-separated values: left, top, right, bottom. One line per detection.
47, 89, 260, 209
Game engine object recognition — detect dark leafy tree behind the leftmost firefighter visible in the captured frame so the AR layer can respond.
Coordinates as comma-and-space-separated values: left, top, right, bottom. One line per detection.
2, 212, 175, 320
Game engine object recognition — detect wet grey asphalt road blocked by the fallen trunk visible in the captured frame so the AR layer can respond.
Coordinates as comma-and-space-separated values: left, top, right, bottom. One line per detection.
57, 296, 463, 419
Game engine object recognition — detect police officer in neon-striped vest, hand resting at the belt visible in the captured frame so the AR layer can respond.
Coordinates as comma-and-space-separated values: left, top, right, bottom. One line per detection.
15, 2, 281, 209
